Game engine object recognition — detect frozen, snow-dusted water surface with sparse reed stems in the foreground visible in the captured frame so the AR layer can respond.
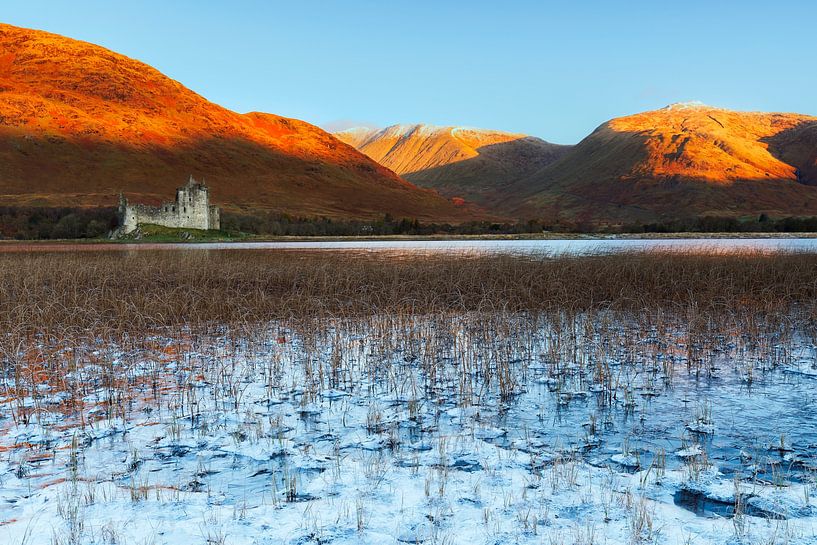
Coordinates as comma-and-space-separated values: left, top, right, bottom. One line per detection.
0, 316, 817, 544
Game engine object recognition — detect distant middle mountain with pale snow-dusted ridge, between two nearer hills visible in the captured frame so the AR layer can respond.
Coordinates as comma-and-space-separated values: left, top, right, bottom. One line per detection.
335, 125, 569, 207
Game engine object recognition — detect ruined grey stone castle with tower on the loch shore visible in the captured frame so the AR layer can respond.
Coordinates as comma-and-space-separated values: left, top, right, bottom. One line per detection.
119, 176, 221, 234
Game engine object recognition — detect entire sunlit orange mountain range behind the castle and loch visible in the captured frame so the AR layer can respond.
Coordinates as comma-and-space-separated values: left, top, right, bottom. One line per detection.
0, 24, 817, 223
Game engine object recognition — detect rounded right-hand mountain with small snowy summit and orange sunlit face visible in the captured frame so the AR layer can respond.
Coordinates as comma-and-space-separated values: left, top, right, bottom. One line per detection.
496, 103, 817, 222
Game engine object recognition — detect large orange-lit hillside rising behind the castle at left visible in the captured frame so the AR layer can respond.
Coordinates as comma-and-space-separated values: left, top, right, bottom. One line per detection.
0, 24, 474, 221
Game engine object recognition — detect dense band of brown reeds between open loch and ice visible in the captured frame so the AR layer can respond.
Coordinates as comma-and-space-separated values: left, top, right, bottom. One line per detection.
0, 251, 817, 335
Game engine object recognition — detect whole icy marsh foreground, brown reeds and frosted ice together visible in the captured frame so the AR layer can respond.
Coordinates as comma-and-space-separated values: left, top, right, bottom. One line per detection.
0, 252, 817, 545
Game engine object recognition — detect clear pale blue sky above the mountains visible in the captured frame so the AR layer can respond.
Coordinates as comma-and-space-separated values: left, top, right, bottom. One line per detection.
0, 0, 817, 143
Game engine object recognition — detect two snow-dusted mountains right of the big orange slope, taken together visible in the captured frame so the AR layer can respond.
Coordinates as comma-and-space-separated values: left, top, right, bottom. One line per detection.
340, 106, 817, 223
